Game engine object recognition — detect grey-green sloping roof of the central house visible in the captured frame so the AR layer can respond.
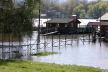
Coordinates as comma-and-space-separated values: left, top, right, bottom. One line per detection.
46, 18, 77, 23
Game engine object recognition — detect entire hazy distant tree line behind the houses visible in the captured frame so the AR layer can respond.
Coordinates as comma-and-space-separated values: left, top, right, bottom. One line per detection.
43, 0, 108, 18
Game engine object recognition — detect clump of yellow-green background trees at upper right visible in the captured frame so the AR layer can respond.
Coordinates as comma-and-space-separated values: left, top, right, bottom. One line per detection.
73, 1, 108, 19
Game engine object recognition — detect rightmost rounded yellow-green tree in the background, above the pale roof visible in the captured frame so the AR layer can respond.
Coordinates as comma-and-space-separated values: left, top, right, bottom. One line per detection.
88, 2, 108, 18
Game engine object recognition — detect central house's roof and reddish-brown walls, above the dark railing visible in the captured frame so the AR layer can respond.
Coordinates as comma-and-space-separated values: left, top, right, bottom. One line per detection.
46, 18, 80, 28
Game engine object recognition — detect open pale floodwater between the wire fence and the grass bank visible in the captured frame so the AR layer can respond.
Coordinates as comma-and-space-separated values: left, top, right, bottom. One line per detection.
31, 42, 108, 68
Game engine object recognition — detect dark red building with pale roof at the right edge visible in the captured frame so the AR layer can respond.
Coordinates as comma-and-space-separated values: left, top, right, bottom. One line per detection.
88, 13, 108, 36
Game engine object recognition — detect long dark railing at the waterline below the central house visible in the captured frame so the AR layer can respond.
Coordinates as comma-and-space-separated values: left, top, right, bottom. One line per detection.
40, 27, 93, 34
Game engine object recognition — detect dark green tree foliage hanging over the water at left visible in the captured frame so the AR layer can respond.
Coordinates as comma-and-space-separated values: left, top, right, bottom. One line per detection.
0, 0, 38, 35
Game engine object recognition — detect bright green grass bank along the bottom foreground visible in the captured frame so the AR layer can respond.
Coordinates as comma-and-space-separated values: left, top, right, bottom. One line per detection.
0, 60, 102, 72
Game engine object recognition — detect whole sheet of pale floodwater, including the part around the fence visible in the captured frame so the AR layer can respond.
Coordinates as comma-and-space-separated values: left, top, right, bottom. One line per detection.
0, 32, 108, 69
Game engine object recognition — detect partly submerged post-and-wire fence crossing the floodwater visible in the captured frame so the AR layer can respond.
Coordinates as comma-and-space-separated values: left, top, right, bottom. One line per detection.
0, 32, 96, 59
